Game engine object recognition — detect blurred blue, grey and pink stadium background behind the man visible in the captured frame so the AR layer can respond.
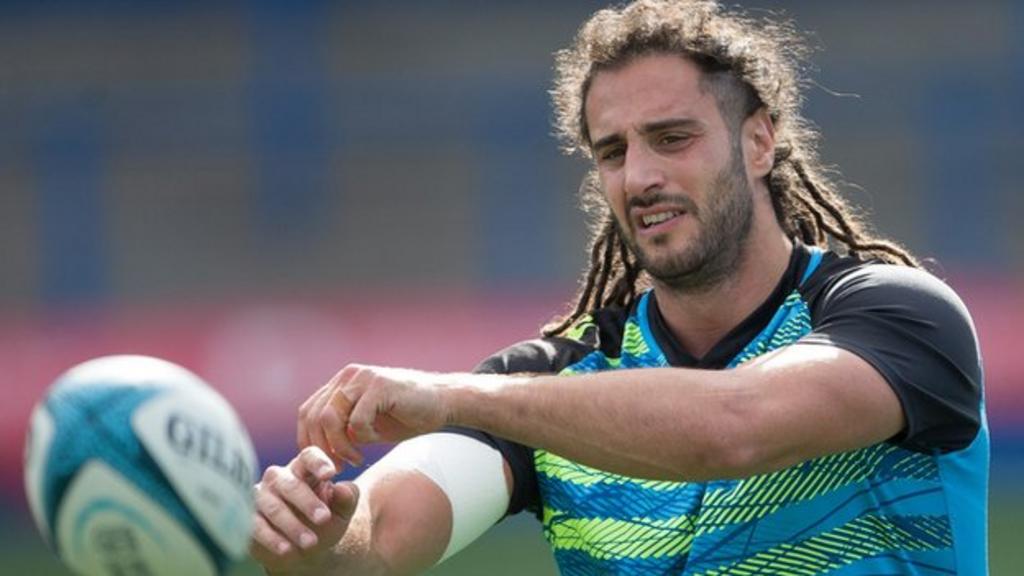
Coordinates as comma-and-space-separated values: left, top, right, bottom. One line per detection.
0, 0, 1024, 574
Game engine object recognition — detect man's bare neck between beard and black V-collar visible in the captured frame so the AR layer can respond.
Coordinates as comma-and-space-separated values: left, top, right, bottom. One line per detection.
654, 224, 793, 358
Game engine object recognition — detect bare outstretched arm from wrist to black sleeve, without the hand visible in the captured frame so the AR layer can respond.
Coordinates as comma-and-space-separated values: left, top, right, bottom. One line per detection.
449, 346, 904, 481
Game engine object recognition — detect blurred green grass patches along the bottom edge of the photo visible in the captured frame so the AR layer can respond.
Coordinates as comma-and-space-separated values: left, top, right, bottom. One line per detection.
0, 492, 1024, 576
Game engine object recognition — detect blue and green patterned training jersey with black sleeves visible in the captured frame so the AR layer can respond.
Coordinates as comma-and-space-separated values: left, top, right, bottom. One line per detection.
454, 246, 988, 576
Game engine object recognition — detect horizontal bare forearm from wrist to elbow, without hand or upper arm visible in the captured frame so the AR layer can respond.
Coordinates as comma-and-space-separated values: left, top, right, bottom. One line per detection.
451, 369, 743, 480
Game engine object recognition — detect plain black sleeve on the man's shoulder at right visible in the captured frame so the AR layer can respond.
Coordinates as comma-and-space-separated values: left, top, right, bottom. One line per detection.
800, 264, 982, 452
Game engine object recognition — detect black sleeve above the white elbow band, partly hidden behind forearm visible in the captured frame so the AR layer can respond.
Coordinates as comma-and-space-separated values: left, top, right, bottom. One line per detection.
444, 338, 592, 516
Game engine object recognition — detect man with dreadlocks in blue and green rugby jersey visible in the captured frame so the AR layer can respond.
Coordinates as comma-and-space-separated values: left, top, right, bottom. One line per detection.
247, 0, 988, 575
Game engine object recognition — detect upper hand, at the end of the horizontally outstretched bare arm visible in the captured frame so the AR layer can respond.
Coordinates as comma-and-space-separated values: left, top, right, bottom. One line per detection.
297, 364, 451, 465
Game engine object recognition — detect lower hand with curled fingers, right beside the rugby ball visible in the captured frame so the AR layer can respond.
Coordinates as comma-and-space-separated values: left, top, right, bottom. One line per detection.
250, 447, 359, 573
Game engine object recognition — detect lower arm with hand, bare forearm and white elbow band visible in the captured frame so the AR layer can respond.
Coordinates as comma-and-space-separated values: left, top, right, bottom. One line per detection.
252, 434, 512, 575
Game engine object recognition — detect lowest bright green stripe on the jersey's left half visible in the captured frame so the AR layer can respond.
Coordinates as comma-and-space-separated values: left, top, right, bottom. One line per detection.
544, 506, 693, 560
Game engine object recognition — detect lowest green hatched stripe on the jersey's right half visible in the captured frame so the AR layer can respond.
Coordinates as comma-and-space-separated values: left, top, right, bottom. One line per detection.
698, 516, 952, 576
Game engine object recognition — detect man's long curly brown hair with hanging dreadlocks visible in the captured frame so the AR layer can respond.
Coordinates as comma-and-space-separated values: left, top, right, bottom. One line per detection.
544, 0, 919, 336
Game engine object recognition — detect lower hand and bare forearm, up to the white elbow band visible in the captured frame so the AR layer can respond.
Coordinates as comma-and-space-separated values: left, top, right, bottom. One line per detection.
252, 448, 452, 575
